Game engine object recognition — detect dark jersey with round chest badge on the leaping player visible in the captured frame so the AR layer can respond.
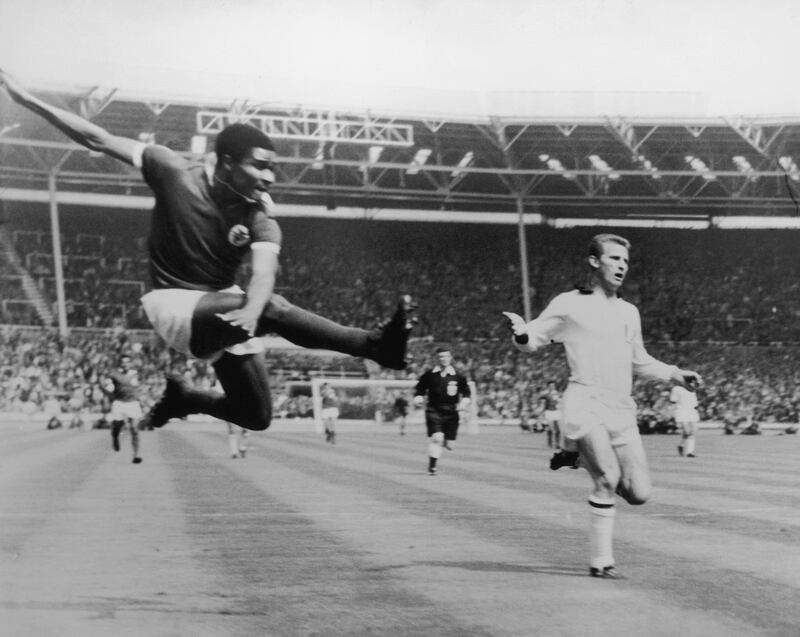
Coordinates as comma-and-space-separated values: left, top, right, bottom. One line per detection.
142, 146, 281, 291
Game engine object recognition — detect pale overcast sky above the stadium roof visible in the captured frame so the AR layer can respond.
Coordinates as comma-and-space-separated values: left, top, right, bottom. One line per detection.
0, 0, 800, 115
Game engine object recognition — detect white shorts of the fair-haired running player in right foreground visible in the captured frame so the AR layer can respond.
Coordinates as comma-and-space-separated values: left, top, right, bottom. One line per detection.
561, 383, 639, 446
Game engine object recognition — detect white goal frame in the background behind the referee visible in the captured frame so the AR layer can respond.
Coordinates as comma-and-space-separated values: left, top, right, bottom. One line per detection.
311, 376, 478, 434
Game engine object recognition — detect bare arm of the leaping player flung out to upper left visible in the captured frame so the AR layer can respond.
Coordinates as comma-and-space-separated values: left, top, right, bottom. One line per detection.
0, 69, 143, 164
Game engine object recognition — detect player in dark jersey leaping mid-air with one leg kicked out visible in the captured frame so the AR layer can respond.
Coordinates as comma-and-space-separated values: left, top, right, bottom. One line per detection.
0, 70, 413, 430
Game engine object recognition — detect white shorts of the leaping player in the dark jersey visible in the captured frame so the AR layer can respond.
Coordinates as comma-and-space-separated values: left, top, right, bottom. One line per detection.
142, 285, 266, 360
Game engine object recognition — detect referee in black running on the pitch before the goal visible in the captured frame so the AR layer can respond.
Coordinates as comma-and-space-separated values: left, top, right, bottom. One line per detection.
414, 347, 472, 476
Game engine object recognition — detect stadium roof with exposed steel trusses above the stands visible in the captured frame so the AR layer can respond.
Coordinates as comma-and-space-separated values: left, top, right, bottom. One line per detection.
0, 88, 800, 226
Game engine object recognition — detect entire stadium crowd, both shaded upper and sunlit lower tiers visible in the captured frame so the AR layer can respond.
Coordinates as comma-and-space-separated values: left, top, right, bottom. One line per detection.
0, 206, 800, 421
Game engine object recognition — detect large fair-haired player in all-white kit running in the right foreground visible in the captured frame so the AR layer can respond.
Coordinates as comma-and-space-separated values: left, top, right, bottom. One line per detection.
504, 234, 700, 579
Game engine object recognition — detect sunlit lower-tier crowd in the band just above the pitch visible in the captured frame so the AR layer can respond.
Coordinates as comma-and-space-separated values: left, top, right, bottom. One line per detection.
0, 328, 800, 422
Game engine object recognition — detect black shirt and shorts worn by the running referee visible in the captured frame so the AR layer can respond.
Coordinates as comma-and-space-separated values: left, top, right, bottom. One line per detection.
414, 365, 472, 440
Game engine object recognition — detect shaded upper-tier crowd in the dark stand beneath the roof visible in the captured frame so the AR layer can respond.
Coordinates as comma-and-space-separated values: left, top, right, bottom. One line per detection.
6, 210, 800, 344
